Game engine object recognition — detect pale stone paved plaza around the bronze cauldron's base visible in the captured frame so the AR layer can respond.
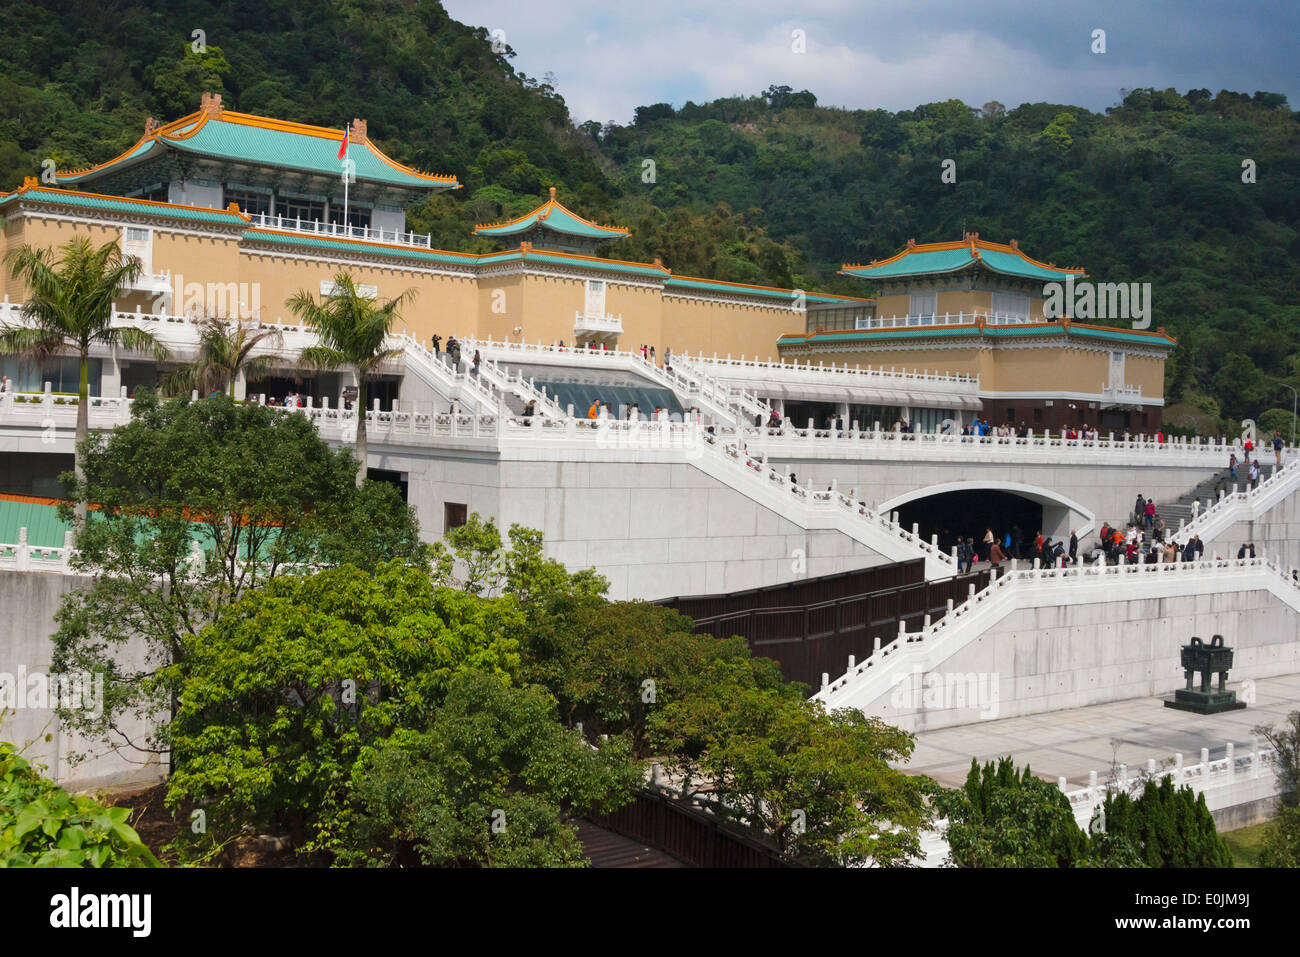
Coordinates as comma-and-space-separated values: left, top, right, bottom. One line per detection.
904, 675, 1300, 787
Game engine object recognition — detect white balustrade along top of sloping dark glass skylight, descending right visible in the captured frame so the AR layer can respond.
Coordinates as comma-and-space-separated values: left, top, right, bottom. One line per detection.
465, 338, 767, 426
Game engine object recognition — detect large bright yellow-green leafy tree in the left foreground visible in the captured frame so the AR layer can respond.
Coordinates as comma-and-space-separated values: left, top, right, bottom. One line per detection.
166, 563, 521, 853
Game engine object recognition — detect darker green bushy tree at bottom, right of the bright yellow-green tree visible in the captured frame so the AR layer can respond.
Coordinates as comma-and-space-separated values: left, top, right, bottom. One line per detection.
338, 672, 641, 867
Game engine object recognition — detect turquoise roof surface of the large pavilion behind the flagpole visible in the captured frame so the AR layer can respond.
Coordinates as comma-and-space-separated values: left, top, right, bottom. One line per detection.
166, 120, 456, 190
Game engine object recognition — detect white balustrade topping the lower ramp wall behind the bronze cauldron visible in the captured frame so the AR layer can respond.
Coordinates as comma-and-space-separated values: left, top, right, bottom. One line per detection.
813, 558, 1300, 723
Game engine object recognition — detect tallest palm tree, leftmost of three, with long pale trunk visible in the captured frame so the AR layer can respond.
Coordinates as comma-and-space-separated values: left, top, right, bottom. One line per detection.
0, 237, 168, 523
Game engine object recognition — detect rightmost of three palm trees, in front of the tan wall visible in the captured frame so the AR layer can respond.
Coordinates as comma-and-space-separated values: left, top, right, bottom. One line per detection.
285, 273, 416, 486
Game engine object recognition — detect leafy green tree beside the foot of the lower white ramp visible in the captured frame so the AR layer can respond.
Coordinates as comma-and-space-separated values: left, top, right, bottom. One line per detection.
650, 658, 931, 866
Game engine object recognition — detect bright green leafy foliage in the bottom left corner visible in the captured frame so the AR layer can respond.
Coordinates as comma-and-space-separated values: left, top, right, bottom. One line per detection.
0, 741, 161, 867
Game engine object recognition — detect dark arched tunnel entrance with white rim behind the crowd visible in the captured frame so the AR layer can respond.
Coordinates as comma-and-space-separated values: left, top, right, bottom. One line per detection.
880, 482, 1093, 559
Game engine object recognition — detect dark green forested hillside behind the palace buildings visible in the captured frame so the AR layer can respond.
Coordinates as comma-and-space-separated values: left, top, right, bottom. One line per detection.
0, 0, 1300, 425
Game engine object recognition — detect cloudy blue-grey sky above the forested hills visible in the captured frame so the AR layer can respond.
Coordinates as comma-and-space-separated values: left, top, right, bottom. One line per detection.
443, 0, 1300, 124
